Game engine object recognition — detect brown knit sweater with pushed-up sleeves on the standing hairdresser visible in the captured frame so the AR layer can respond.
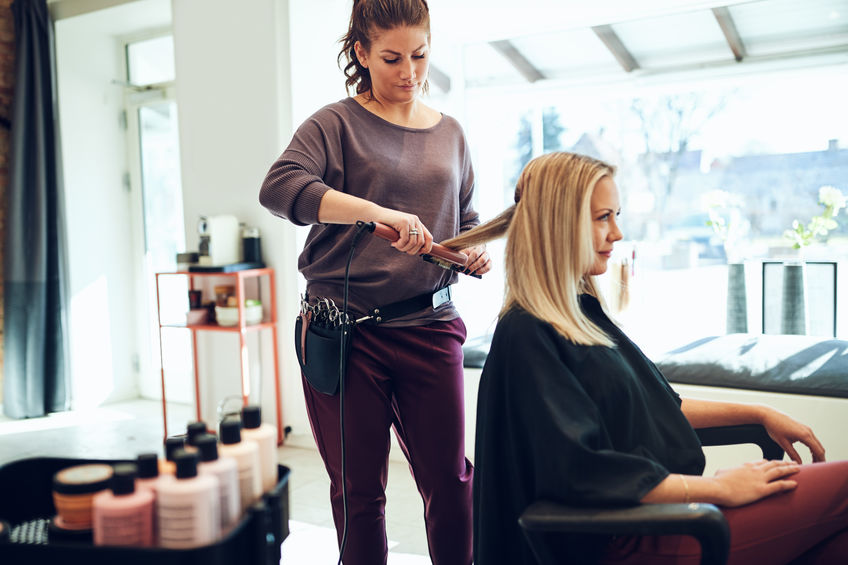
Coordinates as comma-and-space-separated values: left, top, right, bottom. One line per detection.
259, 98, 479, 326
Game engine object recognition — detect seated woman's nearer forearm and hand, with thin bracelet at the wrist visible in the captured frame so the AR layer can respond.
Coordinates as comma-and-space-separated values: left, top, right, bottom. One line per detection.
642, 460, 799, 507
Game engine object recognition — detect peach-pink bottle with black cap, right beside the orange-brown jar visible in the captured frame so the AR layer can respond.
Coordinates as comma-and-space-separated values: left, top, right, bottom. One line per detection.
92, 463, 154, 547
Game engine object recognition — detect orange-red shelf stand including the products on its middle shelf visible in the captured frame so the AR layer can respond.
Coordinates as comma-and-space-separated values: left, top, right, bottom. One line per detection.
156, 268, 283, 444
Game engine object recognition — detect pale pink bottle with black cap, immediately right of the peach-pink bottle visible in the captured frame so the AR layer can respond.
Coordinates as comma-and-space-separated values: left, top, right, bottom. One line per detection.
156, 450, 221, 549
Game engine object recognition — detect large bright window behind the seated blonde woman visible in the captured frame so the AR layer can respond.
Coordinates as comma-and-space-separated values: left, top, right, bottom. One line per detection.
460, 70, 848, 353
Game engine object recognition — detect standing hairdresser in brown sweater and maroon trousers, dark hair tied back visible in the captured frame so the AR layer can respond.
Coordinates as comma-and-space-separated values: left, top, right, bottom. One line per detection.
260, 0, 490, 565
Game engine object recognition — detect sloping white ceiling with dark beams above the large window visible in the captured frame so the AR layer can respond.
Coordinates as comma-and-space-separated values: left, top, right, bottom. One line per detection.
430, 0, 848, 88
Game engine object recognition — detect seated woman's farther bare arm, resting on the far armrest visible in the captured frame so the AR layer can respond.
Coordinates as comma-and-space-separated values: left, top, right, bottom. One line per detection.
680, 398, 824, 463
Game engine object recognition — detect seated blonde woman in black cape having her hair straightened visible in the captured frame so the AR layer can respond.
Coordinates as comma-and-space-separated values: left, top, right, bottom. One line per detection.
445, 153, 848, 565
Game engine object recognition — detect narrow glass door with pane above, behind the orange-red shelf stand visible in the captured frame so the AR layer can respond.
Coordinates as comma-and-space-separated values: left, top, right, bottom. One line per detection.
125, 35, 193, 402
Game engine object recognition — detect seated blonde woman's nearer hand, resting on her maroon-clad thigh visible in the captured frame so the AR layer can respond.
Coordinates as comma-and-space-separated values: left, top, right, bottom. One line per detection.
714, 459, 800, 507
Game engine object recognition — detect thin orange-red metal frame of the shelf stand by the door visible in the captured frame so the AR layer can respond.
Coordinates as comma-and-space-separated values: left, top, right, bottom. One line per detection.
156, 268, 283, 445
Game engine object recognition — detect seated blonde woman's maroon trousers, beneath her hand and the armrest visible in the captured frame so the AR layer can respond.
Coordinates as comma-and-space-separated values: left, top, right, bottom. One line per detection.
603, 461, 848, 565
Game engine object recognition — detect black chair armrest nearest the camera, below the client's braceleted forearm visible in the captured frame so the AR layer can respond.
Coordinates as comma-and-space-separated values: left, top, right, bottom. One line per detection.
518, 500, 730, 565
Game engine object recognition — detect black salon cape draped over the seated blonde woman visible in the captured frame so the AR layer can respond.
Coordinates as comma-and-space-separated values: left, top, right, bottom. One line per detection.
474, 295, 704, 565
